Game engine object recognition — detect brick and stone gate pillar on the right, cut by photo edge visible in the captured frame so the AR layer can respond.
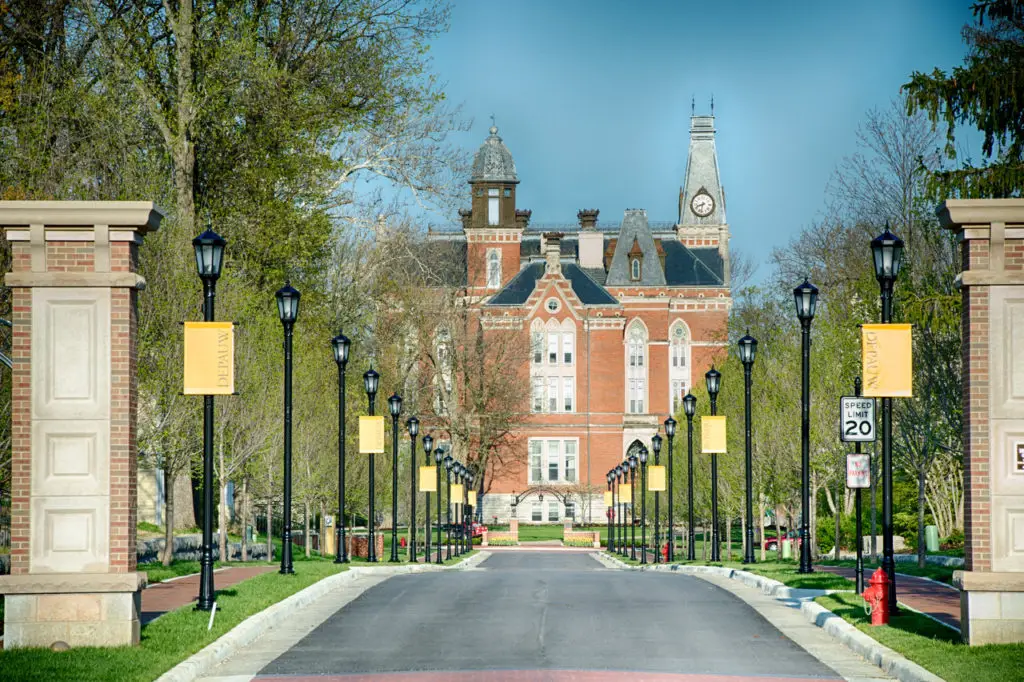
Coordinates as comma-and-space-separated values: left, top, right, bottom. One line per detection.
940, 199, 1024, 644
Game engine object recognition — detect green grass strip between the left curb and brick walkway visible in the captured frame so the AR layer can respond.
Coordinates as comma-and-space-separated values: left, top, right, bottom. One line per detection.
0, 561, 346, 682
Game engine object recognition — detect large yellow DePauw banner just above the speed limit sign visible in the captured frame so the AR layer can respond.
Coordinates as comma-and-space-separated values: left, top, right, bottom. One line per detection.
860, 325, 913, 397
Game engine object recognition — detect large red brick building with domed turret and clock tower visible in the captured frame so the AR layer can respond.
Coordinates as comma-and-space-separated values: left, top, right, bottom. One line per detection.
430, 116, 731, 523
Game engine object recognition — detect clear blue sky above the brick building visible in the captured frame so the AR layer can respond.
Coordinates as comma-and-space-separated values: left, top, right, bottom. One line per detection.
409, 0, 977, 278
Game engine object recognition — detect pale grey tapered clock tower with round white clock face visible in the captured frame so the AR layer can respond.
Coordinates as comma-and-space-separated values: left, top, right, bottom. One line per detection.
676, 116, 729, 283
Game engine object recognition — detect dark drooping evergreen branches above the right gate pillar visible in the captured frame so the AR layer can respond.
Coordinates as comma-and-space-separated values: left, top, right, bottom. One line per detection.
902, 0, 1024, 201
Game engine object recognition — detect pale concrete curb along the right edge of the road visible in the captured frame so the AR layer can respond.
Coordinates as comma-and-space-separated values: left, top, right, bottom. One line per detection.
602, 553, 945, 682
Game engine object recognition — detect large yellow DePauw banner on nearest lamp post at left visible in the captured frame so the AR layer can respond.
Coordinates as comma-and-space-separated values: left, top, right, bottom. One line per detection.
182, 322, 234, 395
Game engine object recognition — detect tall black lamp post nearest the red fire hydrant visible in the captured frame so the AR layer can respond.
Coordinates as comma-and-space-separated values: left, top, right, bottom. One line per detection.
871, 222, 903, 613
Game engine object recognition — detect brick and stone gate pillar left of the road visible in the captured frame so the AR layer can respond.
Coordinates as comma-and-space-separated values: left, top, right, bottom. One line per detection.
0, 202, 163, 648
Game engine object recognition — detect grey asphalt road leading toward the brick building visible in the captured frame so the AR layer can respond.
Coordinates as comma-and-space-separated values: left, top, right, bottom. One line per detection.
253, 552, 841, 680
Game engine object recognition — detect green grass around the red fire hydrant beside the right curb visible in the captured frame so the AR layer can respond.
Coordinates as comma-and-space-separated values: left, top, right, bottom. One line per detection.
815, 594, 1024, 682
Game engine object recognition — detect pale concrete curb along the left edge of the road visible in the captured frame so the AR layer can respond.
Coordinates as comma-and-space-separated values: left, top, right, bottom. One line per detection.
157, 551, 489, 682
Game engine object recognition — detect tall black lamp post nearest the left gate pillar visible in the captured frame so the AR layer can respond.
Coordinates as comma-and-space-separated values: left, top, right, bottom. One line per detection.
193, 227, 225, 611
